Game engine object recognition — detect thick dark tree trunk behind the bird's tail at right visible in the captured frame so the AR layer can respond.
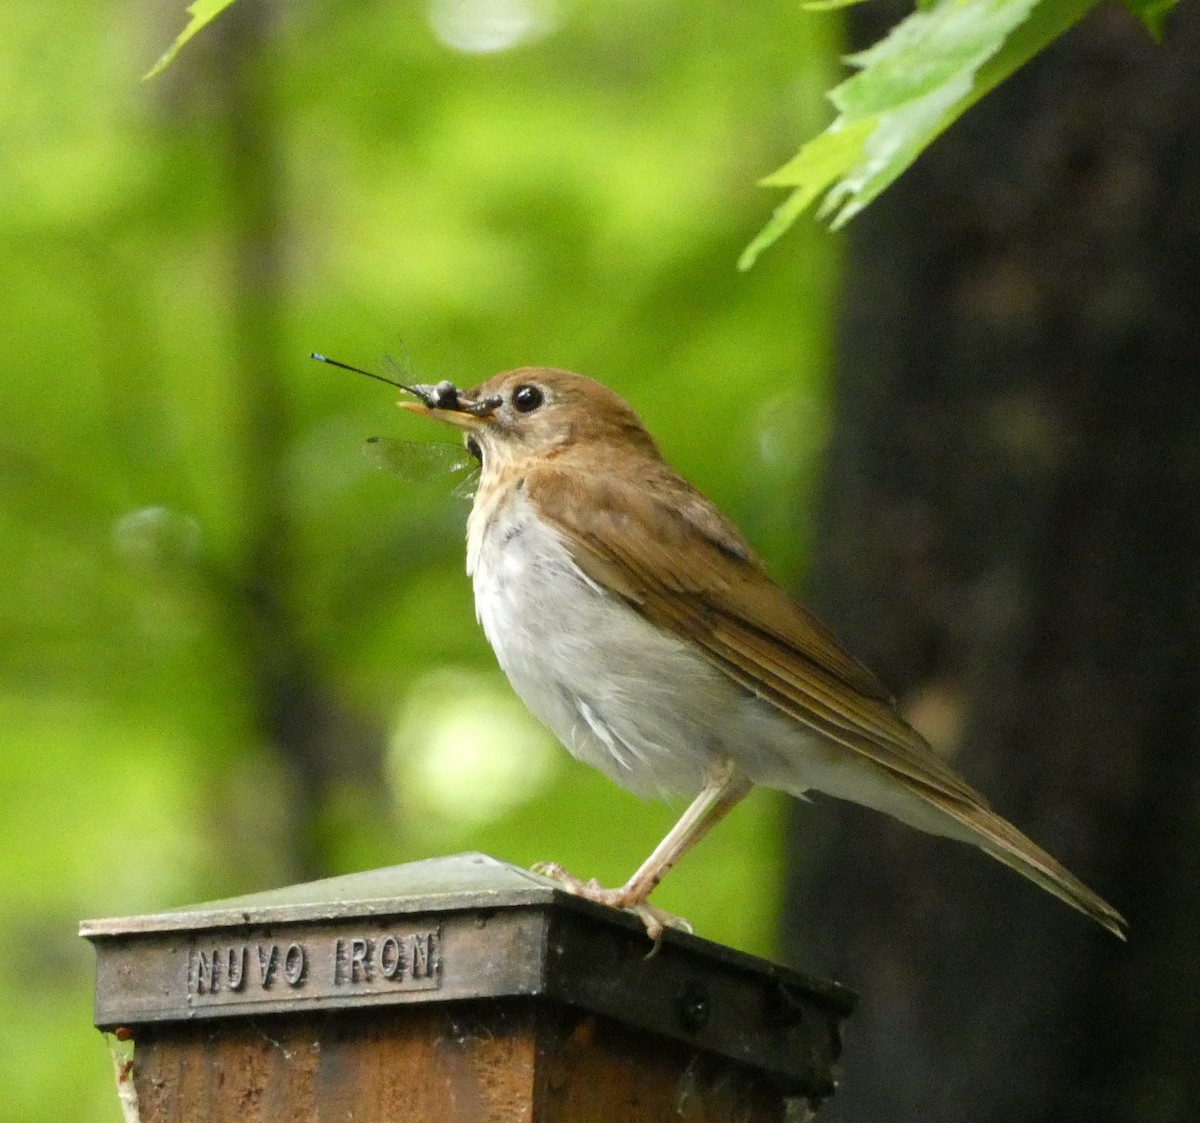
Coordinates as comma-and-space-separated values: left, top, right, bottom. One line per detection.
785, 4, 1200, 1123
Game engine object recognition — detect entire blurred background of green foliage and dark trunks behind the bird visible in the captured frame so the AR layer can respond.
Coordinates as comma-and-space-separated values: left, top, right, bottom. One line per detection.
0, 0, 1200, 1123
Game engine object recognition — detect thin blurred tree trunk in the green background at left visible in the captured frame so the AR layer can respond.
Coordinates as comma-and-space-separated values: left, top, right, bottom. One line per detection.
184, 0, 384, 881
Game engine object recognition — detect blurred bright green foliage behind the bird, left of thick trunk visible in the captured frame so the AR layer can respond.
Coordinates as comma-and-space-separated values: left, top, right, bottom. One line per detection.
0, 0, 836, 1121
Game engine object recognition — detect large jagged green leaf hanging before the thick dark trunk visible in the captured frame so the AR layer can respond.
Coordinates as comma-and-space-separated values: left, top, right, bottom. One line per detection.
738, 0, 1104, 270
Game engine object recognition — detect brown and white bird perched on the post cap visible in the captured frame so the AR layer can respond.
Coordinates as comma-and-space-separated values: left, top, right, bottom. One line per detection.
393, 364, 1127, 939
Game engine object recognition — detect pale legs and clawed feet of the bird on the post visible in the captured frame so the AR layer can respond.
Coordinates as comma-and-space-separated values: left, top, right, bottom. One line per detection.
534, 757, 751, 939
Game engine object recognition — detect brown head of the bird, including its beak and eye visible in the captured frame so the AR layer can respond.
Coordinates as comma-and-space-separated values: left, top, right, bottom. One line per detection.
401, 367, 658, 474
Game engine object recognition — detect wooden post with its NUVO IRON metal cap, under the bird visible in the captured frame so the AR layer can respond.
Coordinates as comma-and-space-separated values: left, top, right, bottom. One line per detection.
82, 854, 854, 1123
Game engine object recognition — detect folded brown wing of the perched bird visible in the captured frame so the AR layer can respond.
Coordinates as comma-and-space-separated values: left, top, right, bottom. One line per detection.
526, 462, 986, 807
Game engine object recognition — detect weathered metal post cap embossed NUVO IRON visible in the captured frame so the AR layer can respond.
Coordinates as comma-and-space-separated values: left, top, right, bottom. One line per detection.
82, 854, 853, 1095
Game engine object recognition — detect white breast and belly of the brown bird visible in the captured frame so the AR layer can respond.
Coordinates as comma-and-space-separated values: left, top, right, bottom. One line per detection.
467, 490, 744, 794
